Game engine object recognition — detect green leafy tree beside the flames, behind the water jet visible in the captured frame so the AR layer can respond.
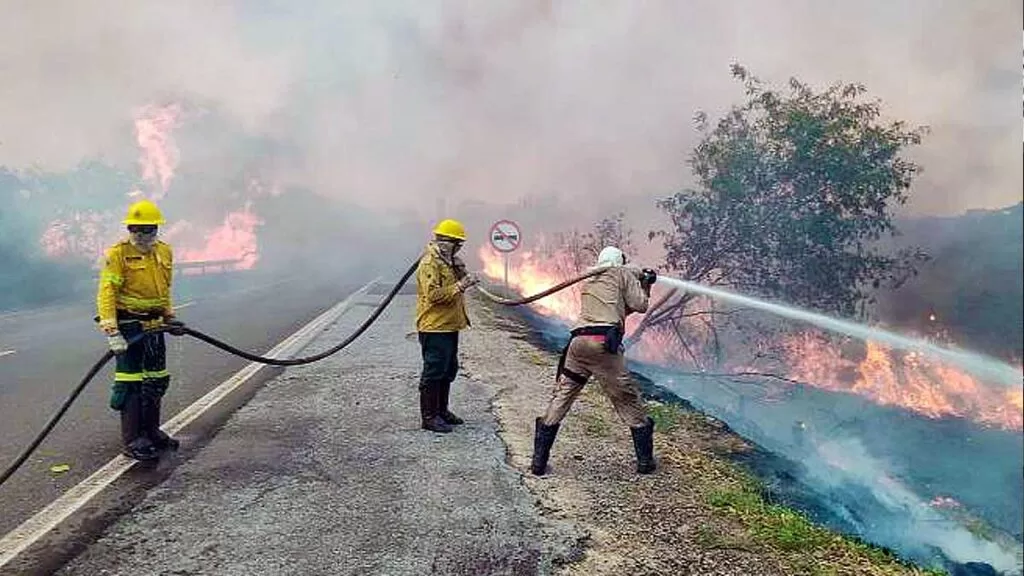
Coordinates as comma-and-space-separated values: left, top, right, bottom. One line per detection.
630, 65, 926, 364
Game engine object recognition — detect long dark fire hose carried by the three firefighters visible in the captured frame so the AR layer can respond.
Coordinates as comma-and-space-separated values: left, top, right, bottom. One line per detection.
0, 258, 605, 486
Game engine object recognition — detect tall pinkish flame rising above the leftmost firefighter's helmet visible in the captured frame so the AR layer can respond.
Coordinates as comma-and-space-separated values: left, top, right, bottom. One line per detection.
135, 104, 181, 194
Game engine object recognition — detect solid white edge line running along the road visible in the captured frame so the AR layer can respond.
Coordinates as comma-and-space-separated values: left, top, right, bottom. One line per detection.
0, 279, 380, 568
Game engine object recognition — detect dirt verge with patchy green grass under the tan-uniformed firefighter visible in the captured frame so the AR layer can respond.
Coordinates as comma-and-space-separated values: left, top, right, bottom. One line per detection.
461, 291, 926, 576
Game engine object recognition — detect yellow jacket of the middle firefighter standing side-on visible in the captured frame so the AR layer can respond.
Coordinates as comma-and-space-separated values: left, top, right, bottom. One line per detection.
416, 242, 469, 332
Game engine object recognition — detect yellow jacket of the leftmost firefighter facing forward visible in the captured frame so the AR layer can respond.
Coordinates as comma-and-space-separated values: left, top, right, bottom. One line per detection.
96, 240, 174, 329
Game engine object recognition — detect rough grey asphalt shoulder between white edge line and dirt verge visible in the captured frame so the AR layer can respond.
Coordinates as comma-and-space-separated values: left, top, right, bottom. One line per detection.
54, 294, 583, 576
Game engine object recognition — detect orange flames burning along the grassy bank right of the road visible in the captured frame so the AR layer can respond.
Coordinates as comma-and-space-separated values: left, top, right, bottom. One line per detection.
478, 241, 1024, 430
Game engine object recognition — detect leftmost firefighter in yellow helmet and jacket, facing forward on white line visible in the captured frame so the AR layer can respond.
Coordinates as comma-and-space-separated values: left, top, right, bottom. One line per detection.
96, 200, 183, 460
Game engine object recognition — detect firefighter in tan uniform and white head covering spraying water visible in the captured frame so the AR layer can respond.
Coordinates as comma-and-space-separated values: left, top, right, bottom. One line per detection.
530, 246, 657, 476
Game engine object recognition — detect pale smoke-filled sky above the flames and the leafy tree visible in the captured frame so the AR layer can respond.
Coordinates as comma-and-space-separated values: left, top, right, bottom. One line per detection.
0, 0, 1024, 213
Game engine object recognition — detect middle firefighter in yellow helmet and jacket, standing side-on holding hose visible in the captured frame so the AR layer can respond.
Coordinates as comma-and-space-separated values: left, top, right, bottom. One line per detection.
416, 219, 477, 433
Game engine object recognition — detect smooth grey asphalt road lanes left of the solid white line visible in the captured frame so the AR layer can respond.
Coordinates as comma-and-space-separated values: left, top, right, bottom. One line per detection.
0, 275, 369, 535
